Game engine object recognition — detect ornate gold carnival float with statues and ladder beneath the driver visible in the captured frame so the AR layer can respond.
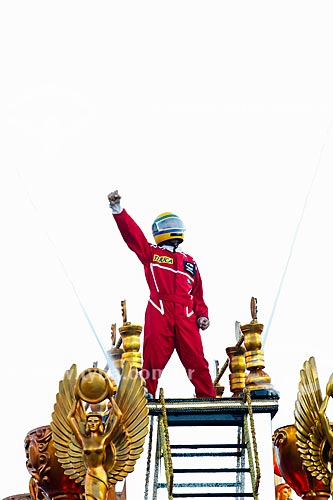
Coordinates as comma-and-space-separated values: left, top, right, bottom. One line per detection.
6, 298, 333, 500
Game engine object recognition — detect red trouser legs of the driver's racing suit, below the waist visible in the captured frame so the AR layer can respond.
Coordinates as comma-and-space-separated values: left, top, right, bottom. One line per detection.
142, 301, 216, 398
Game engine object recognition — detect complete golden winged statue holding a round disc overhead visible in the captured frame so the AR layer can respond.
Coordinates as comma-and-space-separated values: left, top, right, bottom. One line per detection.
51, 361, 149, 500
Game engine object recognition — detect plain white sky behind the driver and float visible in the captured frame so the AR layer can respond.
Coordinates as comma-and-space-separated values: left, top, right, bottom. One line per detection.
0, 1, 333, 498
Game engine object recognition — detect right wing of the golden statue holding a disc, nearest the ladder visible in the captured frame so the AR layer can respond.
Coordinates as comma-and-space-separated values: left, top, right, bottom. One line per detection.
108, 361, 149, 484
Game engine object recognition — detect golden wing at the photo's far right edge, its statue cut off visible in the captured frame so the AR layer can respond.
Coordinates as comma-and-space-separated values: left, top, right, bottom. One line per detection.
294, 357, 330, 484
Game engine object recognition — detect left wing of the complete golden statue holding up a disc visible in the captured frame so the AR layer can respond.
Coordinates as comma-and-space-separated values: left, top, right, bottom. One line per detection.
50, 365, 86, 483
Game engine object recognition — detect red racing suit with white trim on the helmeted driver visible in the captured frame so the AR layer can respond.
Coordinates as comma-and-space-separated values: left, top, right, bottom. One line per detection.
113, 209, 216, 398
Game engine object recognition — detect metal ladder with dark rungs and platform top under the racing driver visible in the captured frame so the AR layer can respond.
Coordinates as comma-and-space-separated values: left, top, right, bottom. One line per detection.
145, 392, 277, 500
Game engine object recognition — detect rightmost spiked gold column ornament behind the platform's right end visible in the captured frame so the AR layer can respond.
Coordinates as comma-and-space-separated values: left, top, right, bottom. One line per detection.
240, 297, 272, 391
